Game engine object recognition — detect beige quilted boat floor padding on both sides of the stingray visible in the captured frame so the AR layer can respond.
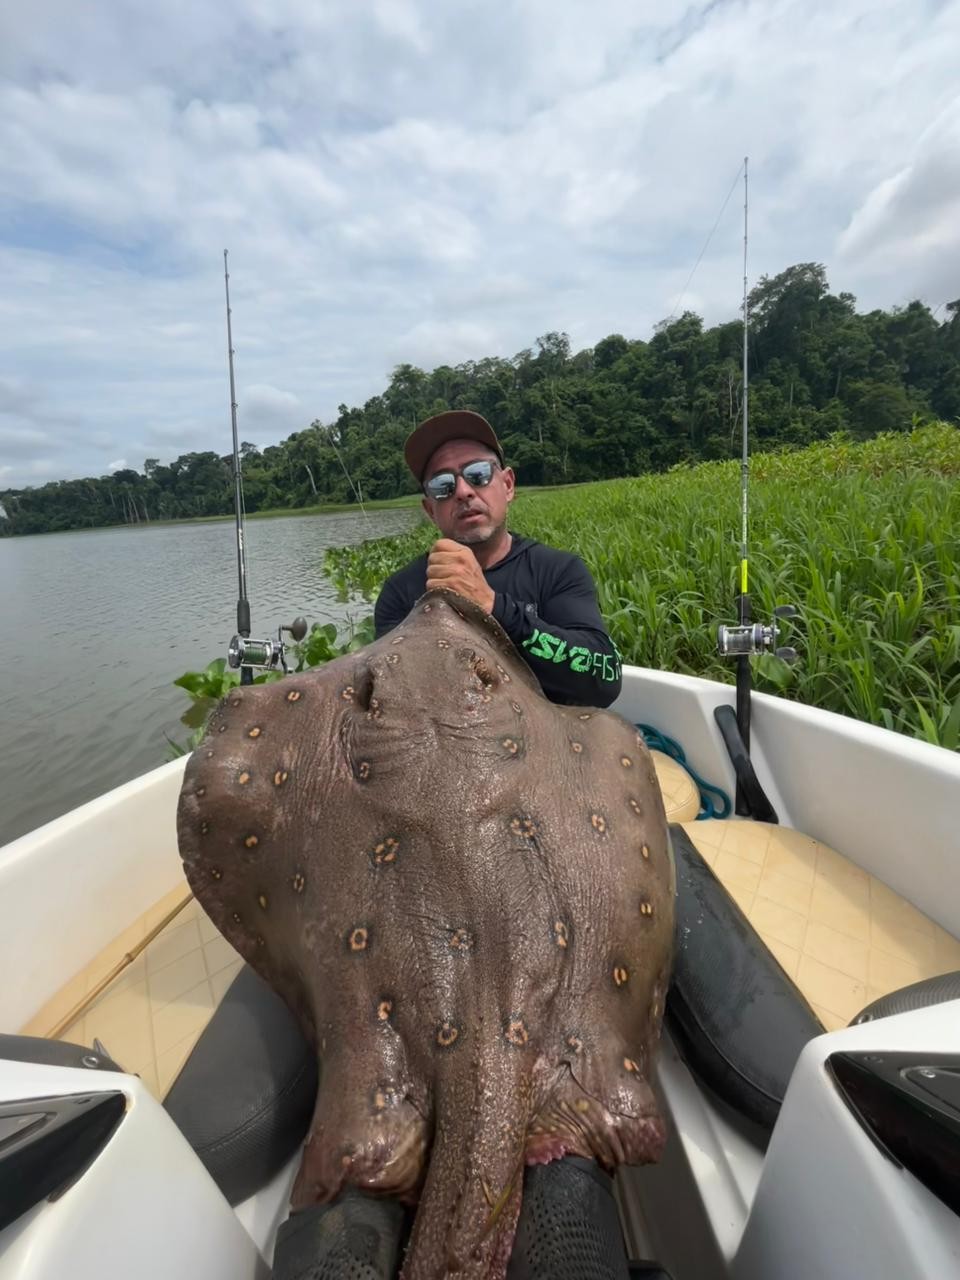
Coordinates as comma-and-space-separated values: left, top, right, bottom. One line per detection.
22, 819, 960, 1098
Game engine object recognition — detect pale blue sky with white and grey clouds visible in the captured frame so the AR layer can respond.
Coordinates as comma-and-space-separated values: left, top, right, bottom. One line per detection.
0, 0, 960, 489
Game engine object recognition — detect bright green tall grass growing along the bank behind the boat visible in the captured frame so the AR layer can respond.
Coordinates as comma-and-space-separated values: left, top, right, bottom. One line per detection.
328, 424, 960, 750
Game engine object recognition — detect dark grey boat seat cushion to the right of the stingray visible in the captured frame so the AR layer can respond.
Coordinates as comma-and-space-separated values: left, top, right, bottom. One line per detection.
667, 824, 823, 1129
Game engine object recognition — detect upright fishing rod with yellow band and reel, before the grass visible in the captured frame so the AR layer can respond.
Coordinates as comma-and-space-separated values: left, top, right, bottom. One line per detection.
714, 156, 796, 822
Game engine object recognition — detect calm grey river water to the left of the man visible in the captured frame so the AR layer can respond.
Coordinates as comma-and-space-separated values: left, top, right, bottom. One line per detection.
0, 511, 415, 846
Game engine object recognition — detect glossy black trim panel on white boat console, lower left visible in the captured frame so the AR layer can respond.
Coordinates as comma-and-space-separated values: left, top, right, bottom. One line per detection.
0, 1091, 127, 1231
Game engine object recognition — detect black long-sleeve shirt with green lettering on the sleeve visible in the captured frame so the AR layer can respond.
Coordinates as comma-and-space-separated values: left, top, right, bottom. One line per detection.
374, 534, 621, 707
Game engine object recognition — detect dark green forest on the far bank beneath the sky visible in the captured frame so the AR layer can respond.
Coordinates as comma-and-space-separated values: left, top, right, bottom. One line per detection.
0, 262, 960, 536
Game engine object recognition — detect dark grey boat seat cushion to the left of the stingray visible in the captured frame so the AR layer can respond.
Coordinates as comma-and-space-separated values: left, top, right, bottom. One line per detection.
164, 965, 317, 1204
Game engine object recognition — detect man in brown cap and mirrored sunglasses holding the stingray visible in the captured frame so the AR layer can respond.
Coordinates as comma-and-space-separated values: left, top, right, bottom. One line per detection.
374, 410, 621, 707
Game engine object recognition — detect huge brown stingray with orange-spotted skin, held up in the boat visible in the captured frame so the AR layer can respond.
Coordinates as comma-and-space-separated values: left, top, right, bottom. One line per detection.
178, 591, 673, 1280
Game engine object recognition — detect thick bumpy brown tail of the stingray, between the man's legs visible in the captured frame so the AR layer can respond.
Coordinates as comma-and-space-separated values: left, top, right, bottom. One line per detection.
401, 1050, 531, 1280
